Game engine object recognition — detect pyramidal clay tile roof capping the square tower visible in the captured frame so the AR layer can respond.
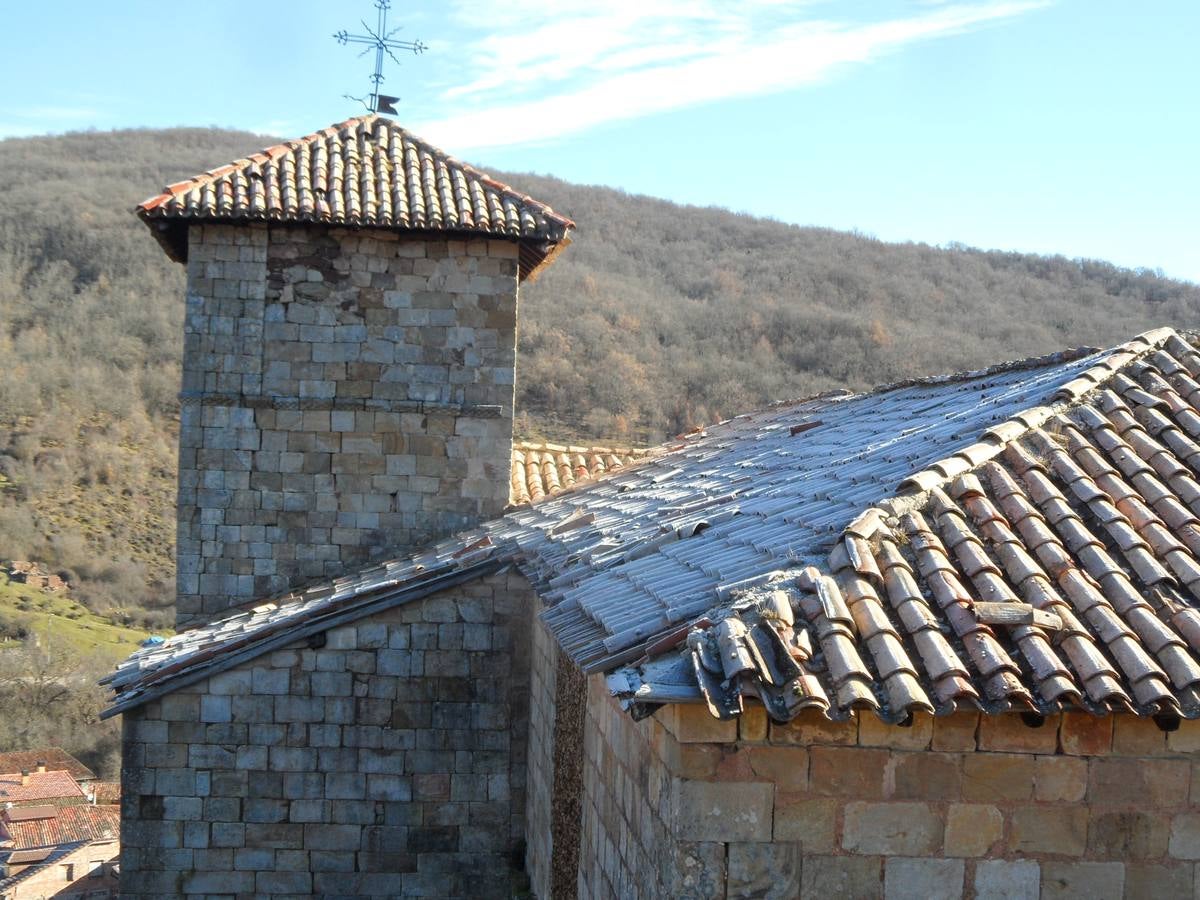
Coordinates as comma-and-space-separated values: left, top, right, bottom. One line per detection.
137, 115, 575, 278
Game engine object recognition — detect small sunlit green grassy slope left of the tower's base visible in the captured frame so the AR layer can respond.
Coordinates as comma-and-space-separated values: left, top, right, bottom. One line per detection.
0, 574, 162, 664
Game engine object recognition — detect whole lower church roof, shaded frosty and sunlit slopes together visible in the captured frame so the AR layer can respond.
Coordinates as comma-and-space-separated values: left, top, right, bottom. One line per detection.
113, 329, 1200, 719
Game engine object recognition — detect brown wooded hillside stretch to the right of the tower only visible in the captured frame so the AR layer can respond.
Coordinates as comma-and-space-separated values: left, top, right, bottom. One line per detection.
511, 175, 1200, 433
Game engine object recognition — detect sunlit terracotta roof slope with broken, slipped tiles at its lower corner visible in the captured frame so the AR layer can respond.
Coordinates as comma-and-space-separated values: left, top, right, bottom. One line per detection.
610, 332, 1200, 720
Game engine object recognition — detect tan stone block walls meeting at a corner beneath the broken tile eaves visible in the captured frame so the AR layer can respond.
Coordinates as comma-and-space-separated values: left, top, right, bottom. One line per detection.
578, 678, 1200, 900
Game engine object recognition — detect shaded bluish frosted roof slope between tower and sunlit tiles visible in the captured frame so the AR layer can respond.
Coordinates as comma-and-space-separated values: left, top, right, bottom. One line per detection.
511, 352, 1128, 671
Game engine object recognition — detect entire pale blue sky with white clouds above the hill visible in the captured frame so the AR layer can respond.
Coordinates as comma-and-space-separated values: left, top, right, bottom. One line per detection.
0, 0, 1200, 282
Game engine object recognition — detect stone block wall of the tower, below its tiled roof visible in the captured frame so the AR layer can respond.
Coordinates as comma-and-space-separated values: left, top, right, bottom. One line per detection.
176, 226, 517, 625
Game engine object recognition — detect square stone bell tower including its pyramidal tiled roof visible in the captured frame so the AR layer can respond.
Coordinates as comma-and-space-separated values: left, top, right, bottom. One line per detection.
138, 115, 572, 628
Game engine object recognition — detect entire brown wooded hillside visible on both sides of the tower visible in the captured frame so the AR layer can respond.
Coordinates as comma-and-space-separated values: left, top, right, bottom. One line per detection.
0, 128, 1200, 628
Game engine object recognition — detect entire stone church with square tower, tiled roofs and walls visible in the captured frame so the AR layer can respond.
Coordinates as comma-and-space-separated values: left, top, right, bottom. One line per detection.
107, 116, 1200, 898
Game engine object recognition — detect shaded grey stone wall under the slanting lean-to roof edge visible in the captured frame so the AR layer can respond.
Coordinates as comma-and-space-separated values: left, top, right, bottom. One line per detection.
121, 572, 530, 898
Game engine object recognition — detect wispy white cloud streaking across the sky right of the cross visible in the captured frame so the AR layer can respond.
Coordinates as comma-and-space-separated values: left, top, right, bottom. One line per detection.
420, 0, 1050, 150
